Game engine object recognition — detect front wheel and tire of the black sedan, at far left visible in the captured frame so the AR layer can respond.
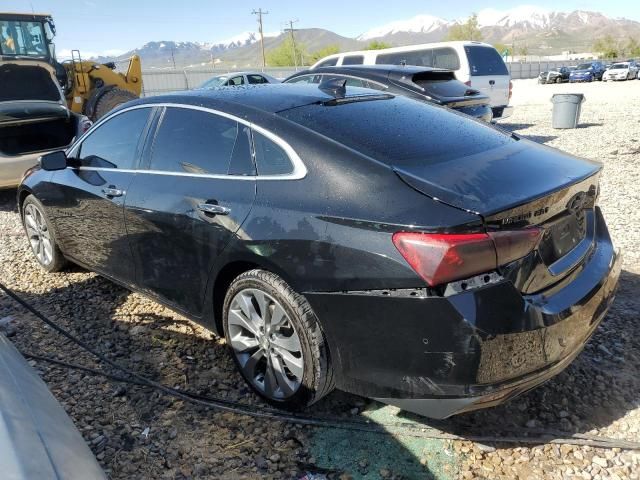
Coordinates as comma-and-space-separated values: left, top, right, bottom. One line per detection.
22, 195, 67, 272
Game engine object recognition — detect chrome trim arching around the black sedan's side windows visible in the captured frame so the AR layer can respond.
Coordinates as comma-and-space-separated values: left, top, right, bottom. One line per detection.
67, 102, 307, 180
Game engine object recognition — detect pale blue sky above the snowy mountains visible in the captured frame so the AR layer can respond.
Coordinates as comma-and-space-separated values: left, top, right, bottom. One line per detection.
6, 0, 640, 53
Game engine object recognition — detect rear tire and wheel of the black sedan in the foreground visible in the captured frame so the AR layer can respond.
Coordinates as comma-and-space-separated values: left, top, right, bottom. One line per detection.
223, 269, 334, 410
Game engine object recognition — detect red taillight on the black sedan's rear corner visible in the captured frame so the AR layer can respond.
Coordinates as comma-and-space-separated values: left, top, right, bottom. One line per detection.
393, 228, 542, 287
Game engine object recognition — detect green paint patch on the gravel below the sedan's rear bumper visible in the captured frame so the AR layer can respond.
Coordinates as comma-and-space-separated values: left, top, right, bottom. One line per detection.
309, 403, 458, 480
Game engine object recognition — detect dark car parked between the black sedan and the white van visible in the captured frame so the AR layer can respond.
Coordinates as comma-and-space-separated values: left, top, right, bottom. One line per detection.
283, 65, 493, 122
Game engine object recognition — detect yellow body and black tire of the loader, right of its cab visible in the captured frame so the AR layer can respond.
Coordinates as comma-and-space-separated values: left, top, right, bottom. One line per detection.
62, 50, 142, 121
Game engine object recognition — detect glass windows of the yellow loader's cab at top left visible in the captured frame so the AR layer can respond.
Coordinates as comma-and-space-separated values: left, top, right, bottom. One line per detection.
0, 20, 49, 58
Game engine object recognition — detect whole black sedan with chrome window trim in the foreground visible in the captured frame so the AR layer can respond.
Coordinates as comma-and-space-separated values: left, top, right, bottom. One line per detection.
18, 81, 620, 417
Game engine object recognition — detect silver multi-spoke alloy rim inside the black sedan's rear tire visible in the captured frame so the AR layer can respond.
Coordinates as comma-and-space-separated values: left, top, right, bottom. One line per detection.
227, 288, 304, 400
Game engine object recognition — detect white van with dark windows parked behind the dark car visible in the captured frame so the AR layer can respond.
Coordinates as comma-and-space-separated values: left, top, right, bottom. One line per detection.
311, 41, 513, 118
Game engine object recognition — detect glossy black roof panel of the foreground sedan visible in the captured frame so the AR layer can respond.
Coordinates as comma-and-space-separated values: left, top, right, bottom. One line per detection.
133, 83, 372, 113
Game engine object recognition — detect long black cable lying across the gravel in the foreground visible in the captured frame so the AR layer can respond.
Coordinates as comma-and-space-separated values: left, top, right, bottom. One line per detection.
0, 282, 640, 450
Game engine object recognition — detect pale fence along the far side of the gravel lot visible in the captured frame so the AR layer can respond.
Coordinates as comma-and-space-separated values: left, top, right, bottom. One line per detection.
142, 60, 604, 97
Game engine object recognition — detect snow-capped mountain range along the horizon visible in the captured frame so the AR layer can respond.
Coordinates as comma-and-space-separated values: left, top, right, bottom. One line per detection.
97, 5, 640, 69
